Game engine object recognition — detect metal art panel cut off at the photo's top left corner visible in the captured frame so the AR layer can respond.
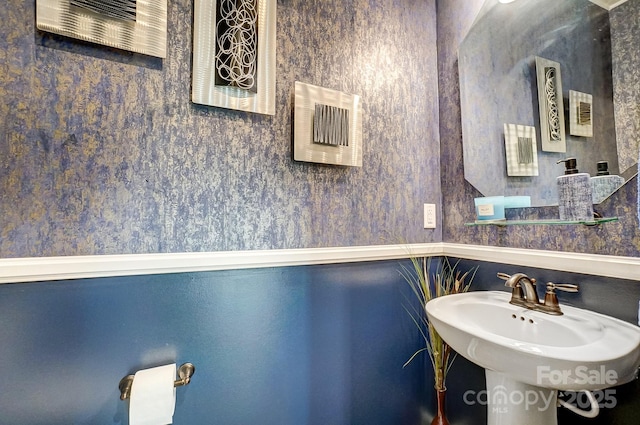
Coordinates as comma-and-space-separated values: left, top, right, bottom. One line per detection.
36, 0, 167, 58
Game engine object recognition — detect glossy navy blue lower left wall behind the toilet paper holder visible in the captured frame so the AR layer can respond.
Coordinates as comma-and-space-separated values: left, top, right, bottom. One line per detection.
0, 261, 433, 425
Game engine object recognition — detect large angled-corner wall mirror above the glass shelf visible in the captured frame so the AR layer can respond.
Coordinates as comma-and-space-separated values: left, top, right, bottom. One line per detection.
458, 0, 640, 206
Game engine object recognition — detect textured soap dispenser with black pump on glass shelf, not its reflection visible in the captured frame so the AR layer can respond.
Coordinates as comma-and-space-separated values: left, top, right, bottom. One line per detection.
557, 158, 593, 221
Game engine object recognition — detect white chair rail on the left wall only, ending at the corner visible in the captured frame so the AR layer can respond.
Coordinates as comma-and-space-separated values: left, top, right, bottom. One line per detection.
0, 243, 442, 283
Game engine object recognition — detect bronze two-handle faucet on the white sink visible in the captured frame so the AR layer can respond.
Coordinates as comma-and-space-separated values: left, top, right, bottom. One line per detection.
498, 273, 578, 316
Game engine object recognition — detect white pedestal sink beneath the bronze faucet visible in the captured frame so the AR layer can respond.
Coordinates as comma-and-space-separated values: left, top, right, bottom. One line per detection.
426, 291, 640, 425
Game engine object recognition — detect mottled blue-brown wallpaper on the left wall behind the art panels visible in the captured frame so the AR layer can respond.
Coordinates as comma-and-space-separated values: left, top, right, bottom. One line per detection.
0, 0, 441, 257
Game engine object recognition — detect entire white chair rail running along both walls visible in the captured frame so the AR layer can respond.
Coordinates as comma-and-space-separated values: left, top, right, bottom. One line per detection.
0, 243, 640, 283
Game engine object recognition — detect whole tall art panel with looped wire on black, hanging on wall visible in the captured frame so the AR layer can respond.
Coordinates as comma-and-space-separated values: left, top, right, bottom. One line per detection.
191, 0, 276, 115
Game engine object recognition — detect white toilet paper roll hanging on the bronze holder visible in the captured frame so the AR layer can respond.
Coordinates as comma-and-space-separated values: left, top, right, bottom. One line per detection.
129, 363, 176, 425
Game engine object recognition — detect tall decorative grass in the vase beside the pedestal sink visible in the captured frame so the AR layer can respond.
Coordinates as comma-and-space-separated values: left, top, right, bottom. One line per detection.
400, 257, 478, 390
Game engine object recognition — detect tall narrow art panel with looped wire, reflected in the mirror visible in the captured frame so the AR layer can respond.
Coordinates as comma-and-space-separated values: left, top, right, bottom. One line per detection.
536, 56, 567, 152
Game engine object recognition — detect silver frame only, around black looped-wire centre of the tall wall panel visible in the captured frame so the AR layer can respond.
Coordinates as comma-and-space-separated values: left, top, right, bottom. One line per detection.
191, 0, 276, 115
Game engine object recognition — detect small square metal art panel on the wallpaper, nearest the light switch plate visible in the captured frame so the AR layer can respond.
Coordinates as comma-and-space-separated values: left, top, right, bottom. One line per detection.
293, 81, 362, 167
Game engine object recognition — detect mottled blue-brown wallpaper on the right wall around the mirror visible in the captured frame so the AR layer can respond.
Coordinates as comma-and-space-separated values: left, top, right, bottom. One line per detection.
438, 0, 640, 257
